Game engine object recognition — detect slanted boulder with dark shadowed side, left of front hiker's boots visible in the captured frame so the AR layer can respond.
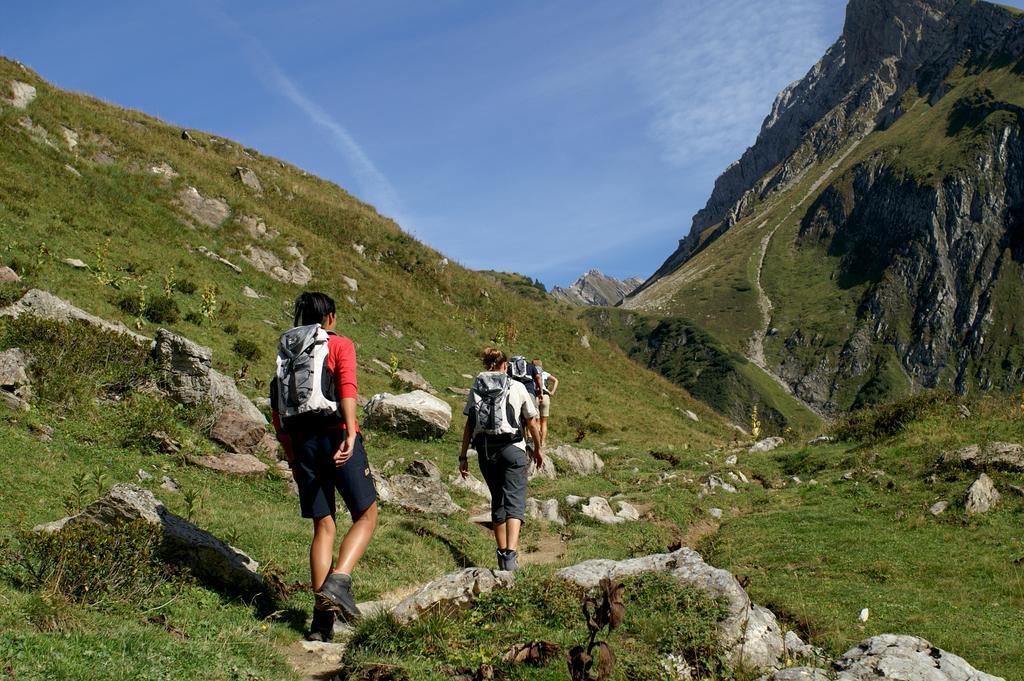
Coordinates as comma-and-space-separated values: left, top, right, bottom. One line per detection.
36, 482, 263, 593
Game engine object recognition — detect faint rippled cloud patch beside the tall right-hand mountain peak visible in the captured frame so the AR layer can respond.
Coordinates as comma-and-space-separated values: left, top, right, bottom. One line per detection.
640, 0, 839, 165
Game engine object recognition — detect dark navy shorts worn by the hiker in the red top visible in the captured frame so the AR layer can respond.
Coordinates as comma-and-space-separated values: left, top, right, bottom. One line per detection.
292, 428, 377, 522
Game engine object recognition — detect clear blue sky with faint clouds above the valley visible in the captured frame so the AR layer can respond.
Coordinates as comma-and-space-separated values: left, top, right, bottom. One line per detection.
0, 0, 845, 286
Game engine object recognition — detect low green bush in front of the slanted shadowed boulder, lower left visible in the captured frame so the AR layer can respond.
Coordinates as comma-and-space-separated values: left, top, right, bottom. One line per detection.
2, 520, 171, 603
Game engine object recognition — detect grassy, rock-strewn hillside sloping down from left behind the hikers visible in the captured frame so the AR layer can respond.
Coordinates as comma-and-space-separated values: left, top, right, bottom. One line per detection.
0, 55, 724, 440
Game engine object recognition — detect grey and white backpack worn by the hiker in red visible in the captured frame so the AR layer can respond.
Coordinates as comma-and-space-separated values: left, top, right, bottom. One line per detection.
270, 324, 342, 431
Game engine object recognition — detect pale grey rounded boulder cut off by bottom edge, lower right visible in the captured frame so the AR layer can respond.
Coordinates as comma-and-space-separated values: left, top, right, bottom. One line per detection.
761, 634, 1005, 681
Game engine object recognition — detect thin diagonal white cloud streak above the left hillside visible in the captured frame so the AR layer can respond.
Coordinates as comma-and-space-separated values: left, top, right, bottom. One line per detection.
199, 3, 413, 225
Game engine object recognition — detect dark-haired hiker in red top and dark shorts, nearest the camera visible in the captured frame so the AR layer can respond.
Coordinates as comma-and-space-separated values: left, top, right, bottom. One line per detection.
270, 292, 377, 641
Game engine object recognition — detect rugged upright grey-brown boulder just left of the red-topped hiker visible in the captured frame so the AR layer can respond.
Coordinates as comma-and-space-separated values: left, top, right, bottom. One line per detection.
153, 329, 266, 425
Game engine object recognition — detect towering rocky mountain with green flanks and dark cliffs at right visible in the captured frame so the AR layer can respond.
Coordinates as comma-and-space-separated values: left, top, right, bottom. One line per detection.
624, 0, 1024, 412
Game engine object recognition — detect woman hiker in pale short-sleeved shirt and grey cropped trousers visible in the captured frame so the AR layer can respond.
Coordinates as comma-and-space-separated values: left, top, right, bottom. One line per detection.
459, 347, 544, 570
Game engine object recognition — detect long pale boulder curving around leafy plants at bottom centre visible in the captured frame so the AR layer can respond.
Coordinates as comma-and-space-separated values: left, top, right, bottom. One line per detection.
558, 547, 785, 669
